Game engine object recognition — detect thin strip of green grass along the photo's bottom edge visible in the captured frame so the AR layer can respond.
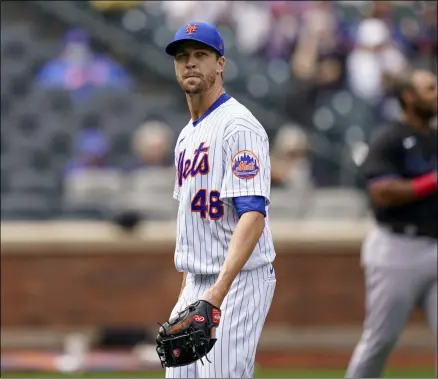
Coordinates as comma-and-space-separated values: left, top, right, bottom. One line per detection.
1, 369, 436, 378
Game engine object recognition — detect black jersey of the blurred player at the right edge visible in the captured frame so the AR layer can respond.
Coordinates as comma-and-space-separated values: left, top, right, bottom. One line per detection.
362, 123, 438, 228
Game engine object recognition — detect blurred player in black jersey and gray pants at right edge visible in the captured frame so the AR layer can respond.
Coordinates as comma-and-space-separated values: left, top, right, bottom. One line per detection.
346, 70, 438, 378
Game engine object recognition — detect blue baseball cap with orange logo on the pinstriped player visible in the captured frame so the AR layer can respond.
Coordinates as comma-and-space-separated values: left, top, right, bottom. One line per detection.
166, 21, 225, 56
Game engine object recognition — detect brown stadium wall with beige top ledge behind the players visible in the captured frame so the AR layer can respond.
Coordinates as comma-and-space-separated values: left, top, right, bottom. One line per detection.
1, 221, 423, 328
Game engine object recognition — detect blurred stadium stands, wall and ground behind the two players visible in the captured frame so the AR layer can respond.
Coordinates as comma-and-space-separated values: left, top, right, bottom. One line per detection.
1, 0, 437, 377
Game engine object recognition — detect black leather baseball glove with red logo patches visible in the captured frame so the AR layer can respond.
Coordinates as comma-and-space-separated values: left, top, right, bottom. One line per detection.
157, 300, 221, 367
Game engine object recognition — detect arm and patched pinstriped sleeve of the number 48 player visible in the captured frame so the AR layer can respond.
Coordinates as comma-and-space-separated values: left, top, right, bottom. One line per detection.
201, 117, 271, 308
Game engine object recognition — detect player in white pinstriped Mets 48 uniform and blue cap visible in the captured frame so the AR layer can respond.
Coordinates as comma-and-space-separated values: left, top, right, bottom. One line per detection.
161, 22, 276, 378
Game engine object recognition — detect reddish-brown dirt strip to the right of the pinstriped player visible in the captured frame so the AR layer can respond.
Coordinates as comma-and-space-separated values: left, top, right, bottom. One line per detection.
256, 349, 436, 369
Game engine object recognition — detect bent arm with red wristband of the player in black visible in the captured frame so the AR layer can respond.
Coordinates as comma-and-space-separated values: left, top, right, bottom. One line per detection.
362, 133, 437, 208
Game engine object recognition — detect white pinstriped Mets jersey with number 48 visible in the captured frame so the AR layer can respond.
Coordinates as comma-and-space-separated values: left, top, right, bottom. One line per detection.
174, 97, 275, 274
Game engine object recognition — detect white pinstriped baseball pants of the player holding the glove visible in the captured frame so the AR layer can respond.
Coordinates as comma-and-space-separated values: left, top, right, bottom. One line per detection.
166, 265, 276, 378
